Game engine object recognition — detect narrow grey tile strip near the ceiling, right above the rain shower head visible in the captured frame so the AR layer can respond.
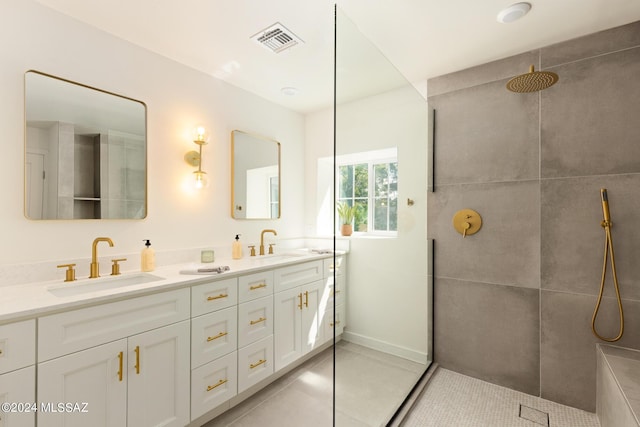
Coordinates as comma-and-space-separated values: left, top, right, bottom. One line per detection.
540, 21, 640, 68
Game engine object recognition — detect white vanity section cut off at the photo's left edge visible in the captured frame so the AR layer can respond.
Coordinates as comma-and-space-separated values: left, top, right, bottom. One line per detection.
0, 320, 36, 427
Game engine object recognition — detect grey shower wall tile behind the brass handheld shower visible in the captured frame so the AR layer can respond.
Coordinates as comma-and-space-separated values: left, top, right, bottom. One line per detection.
540, 174, 640, 299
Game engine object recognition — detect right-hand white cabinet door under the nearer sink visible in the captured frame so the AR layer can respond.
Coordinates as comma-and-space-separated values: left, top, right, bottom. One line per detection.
126, 321, 190, 427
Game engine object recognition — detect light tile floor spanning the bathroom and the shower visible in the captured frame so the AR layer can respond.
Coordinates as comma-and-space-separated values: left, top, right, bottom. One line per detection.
203, 341, 600, 427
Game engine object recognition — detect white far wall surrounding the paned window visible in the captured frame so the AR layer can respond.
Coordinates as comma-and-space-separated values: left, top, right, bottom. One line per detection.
305, 86, 430, 361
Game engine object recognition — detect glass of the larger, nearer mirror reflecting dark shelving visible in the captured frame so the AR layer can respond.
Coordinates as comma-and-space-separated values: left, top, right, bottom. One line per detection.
25, 71, 147, 220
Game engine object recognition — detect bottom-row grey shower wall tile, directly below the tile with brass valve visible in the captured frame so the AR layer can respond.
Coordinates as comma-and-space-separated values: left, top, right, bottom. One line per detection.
434, 280, 540, 395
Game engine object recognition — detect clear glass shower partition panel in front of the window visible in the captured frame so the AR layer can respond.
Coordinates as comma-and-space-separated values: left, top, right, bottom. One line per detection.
334, 8, 432, 426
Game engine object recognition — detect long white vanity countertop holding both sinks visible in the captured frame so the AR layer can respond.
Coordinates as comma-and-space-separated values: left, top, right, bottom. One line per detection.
0, 250, 340, 323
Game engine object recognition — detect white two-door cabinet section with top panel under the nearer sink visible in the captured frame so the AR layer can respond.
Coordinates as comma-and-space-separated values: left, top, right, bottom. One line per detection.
37, 289, 190, 427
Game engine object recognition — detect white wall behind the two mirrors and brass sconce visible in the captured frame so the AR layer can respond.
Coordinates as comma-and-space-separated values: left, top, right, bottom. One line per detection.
0, 0, 304, 284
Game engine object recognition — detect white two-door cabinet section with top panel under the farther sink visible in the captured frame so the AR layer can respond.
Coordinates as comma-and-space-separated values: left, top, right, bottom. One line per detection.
274, 260, 328, 370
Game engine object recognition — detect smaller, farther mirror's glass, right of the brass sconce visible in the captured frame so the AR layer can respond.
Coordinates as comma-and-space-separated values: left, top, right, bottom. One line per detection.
231, 130, 280, 219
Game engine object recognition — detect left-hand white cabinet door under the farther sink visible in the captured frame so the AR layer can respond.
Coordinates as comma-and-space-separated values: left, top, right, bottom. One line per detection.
273, 287, 303, 371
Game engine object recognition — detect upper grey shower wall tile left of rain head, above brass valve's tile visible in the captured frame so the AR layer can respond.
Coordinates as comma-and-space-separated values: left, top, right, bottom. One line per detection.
429, 80, 539, 188
